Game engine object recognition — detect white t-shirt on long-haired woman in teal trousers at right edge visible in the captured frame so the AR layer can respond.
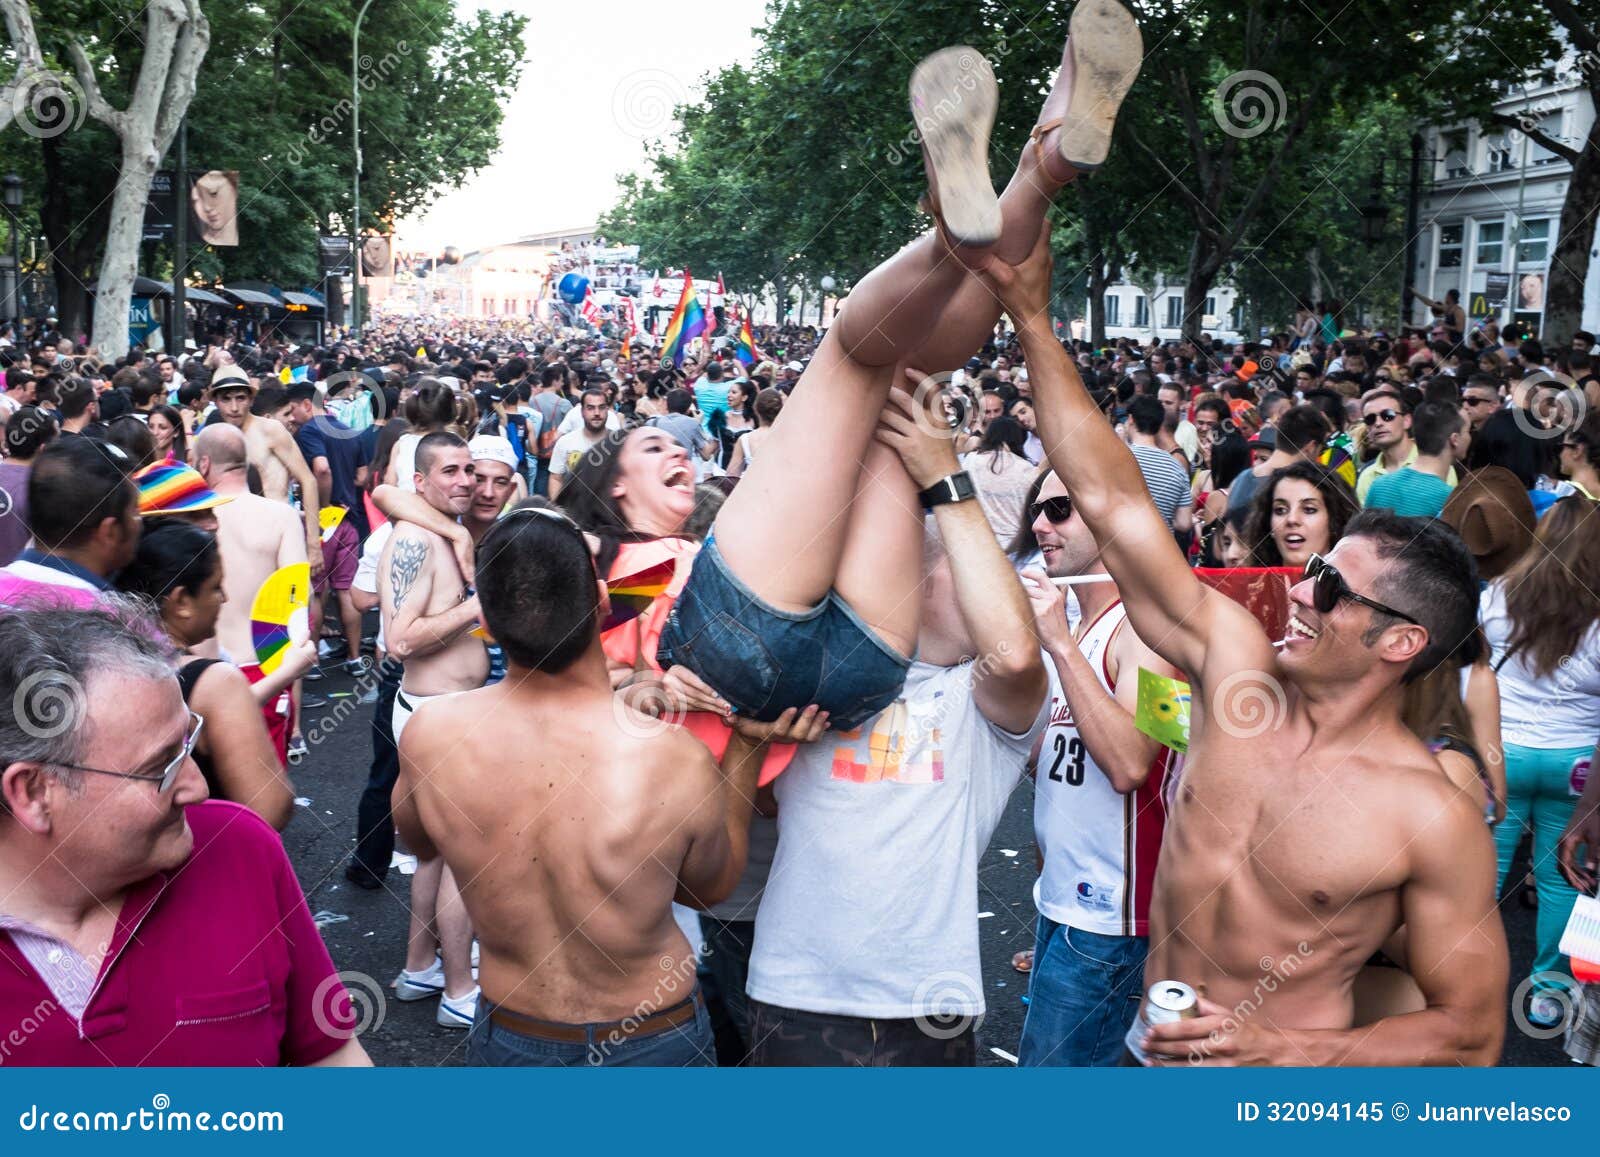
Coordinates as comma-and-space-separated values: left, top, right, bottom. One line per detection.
1478, 579, 1600, 747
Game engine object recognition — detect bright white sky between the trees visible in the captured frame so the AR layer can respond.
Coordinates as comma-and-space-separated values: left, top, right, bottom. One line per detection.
397, 0, 765, 251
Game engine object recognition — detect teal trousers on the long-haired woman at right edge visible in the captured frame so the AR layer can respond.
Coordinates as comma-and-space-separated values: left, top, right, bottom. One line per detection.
1494, 743, 1594, 989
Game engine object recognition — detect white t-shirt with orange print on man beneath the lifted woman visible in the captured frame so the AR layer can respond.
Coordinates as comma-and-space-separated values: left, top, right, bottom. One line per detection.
749, 663, 1046, 1019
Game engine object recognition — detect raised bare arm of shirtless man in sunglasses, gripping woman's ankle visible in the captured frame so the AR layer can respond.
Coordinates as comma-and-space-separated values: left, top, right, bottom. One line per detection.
986, 226, 1270, 677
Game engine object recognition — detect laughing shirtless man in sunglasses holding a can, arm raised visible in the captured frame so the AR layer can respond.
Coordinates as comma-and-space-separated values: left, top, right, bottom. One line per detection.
986, 225, 1509, 1064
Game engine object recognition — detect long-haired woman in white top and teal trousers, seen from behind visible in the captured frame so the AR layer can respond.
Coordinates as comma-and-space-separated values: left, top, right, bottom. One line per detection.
1480, 494, 1600, 1027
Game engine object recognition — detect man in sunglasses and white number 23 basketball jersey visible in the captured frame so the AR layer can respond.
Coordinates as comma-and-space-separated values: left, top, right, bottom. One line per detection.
1018, 474, 1178, 1066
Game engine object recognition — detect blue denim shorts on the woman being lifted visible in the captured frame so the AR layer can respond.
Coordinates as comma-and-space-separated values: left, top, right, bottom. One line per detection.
656, 538, 910, 731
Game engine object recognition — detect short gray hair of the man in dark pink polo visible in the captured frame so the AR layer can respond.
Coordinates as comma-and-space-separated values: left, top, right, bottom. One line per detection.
0, 595, 176, 786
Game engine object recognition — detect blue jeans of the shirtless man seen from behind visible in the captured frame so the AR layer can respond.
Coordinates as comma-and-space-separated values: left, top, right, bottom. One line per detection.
467, 989, 717, 1069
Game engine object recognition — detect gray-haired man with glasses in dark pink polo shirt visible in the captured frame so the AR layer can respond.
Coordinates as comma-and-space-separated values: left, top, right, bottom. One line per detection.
0, 605, 370, 1066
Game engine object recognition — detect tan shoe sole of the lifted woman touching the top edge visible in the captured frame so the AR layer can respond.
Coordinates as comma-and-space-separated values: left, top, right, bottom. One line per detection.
1056, 0, 1144, 173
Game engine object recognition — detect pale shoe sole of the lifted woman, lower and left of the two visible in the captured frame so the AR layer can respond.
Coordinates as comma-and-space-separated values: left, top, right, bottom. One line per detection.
910, 45, 1000, 245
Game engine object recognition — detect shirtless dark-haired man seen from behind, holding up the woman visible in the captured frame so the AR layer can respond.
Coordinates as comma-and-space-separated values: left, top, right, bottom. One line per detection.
395, 510, 822, 1064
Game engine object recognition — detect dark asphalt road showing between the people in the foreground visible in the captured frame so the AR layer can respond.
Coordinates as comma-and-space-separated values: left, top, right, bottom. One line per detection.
283, 664, 1568, 1066
